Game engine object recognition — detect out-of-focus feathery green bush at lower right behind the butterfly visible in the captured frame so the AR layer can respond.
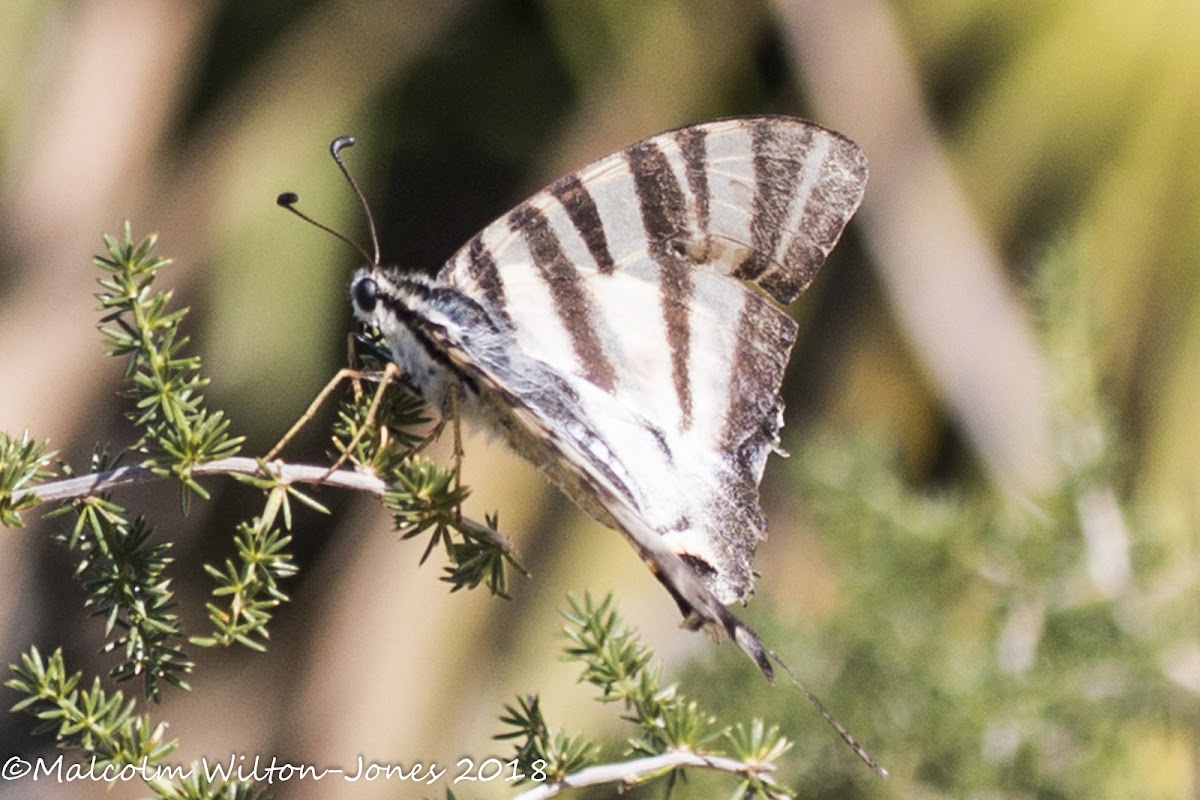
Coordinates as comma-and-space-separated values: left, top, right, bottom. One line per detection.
753, 437, 1183, 796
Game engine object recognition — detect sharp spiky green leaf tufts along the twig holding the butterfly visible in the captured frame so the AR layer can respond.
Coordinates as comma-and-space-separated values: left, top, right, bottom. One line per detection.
0, 224, 516, 671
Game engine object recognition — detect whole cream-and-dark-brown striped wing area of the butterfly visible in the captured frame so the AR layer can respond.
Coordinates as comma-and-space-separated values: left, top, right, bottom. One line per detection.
438, 116, 866, 616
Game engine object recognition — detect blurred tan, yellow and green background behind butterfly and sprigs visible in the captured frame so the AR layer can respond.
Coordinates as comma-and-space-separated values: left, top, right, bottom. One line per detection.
0, 0, 1200, 798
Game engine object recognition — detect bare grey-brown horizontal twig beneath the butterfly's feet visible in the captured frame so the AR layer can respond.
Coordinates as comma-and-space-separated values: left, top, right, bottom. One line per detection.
13, 456, 512, 553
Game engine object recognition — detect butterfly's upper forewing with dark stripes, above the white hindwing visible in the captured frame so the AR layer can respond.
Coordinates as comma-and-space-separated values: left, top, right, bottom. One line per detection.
439, 116, 866, 452
